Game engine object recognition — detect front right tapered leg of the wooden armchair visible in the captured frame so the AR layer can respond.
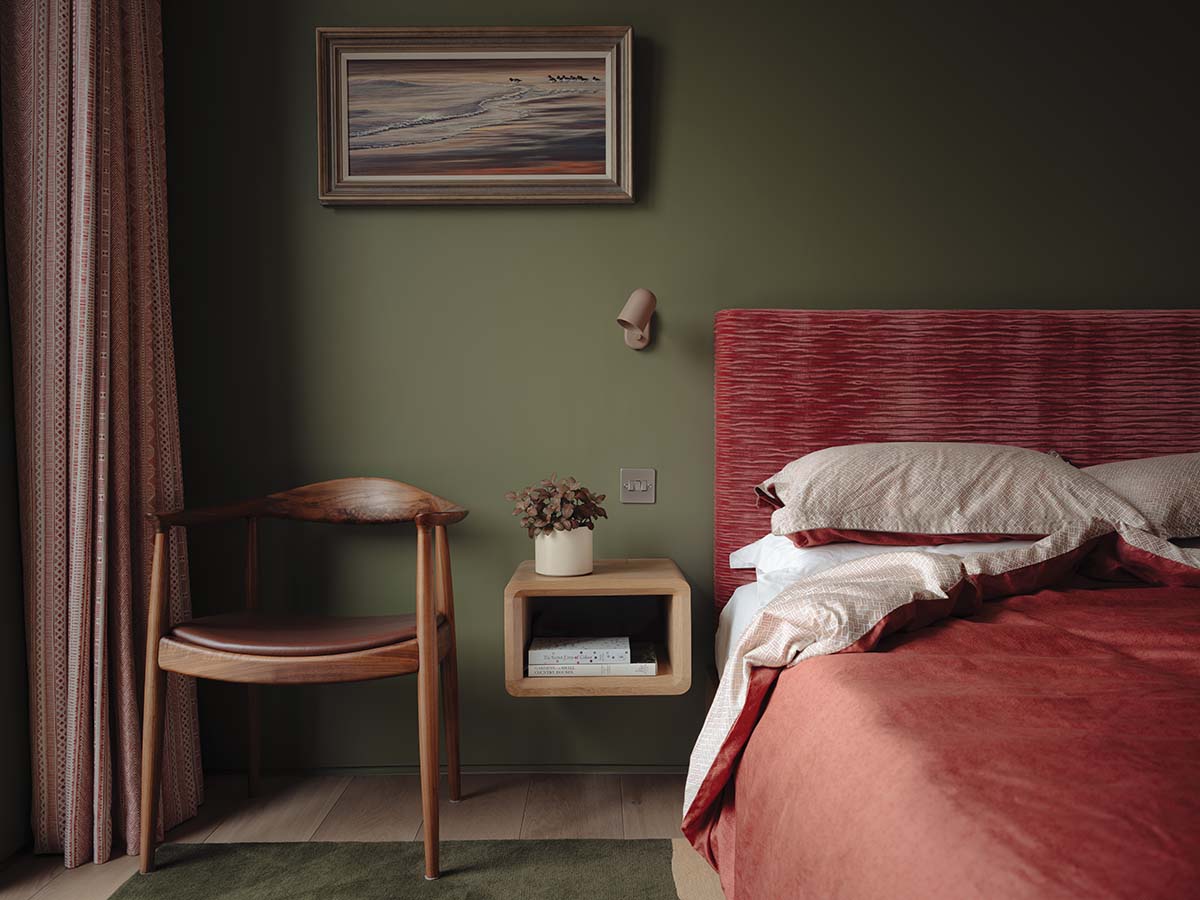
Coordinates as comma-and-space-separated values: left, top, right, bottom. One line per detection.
416, 526, 439, 881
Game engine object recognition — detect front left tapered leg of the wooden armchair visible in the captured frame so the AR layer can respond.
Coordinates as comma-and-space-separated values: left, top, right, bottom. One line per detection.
139, 532, 167, 875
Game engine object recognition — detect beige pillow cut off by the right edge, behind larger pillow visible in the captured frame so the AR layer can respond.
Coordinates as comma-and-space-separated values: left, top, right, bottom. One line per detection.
1084, 454, 1200, 538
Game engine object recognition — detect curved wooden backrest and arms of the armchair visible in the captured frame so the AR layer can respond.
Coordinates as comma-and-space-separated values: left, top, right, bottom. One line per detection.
154, 478, 467, 527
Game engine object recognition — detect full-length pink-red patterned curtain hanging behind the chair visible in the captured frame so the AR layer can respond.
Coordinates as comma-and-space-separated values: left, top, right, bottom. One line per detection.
0, 0, 203, 866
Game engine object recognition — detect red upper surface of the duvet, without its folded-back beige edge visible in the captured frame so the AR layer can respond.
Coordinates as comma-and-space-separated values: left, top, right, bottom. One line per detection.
692, 576, 1200, 900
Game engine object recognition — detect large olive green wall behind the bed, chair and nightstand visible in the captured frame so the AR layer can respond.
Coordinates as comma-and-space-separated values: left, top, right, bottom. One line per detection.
166, 0, 1200, 768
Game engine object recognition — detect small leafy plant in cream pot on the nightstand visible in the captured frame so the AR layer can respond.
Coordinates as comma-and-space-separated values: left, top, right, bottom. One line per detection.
504, 475, 608, 575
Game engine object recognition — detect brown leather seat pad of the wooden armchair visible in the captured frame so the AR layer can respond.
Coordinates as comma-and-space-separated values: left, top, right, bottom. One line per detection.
170, 612, 443, 656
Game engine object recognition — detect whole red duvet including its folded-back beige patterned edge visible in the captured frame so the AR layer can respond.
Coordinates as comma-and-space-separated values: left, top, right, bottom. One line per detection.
684, 521, 1200, 898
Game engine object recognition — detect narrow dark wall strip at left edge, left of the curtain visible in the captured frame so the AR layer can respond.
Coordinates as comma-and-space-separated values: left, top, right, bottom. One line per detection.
0, 188, 30, 862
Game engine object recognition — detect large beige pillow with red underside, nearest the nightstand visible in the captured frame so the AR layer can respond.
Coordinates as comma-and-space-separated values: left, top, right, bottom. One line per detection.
757, 443, 1148, 546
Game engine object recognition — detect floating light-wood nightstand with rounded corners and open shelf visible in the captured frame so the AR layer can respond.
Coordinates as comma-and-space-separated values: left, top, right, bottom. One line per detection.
504, 559, 691, 697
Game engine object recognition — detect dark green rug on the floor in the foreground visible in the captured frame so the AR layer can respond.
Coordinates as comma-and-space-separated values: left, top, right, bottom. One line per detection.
113, 840, 696, 900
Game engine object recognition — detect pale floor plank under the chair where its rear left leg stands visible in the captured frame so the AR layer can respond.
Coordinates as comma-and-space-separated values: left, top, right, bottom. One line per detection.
205, 775, 350, 844
